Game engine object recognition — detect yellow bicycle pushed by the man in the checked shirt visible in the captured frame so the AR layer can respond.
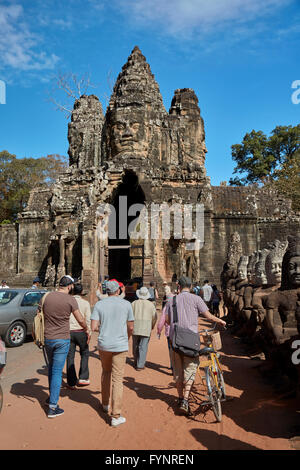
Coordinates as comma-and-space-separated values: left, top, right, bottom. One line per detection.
197, 324, 226, 423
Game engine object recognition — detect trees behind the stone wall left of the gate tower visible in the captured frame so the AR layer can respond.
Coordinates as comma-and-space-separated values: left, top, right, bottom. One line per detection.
0, 150, 67, 223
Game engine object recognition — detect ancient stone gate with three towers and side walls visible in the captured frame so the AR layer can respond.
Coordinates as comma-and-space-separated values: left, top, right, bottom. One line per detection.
0, 47, 299, 302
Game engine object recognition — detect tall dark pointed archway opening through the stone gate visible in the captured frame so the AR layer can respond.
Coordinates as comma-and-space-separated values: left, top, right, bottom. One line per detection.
108, 170, 145, 283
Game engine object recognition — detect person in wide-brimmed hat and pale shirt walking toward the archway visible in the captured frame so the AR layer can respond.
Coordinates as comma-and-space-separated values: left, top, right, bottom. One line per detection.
132, 287, 157, 370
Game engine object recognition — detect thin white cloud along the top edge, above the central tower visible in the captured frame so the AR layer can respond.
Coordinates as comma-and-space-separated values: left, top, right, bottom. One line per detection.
115, 0, 292, 35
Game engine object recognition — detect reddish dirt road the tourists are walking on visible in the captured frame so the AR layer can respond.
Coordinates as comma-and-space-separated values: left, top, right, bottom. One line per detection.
0, 320, 299, 450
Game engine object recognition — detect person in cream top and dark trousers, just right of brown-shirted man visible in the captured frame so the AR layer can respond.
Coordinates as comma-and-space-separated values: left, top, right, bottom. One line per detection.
67, 284, 91, 389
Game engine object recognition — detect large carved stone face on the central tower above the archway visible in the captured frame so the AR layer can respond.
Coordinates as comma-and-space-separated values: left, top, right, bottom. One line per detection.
110, 108, 148, 157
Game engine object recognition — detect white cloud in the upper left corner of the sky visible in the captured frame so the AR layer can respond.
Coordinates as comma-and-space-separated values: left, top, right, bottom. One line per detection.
0, 4, 59, 72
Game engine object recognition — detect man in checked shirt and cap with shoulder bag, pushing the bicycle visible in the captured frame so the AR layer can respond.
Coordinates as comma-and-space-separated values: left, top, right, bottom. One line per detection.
166, 276, 226, 414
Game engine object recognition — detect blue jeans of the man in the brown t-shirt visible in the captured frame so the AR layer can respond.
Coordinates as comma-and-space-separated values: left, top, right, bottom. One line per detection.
45, 339, 70, 408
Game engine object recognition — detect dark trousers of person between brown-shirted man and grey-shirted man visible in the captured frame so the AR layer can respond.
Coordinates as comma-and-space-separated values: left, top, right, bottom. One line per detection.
67, 331, 90, 387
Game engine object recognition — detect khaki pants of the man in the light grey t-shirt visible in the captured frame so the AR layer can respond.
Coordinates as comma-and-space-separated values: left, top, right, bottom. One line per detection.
99, 351, 127, 418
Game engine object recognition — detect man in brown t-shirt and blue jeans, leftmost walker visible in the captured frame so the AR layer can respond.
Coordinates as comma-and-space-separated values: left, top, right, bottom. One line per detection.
39, 276, 88, 418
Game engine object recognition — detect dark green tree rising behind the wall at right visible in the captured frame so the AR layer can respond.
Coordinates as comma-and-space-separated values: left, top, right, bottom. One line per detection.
229, 124, 300, 210
